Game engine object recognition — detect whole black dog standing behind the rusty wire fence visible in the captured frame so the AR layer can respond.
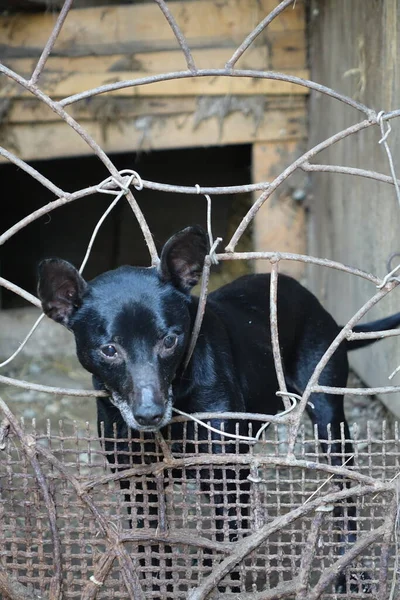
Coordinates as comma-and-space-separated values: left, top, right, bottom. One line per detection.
38, 227, 400, 592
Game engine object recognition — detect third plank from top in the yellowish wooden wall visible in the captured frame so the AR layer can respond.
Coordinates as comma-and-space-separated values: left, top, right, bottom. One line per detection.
0, 69, 309, 98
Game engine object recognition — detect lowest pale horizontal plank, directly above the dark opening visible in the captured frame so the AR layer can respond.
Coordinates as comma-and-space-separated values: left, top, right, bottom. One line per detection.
0, 110, 306, 160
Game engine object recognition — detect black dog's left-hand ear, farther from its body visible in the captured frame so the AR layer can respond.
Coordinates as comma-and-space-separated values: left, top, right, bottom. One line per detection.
38, 258, 87, 327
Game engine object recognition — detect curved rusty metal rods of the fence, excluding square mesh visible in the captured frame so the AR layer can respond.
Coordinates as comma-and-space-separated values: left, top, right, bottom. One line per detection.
0, 0, 400, 600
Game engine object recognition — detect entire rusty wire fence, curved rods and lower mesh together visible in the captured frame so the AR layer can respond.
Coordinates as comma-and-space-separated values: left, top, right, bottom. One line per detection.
0, 0, 400, 600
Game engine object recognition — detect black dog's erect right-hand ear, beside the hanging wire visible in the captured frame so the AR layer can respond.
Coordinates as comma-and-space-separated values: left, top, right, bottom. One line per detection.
158, 225, 208, 292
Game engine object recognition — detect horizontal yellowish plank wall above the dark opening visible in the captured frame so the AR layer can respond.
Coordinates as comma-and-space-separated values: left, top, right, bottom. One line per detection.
0, 0, 308, 160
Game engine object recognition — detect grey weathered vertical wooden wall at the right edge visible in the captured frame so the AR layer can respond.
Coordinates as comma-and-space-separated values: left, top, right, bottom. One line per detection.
309, 0, 400, 416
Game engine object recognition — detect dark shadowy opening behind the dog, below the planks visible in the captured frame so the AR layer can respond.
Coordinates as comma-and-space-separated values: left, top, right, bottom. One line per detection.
0, 145, 251, 308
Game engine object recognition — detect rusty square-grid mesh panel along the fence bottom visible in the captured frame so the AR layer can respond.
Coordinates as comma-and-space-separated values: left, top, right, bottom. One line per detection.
0, 424, 400, 600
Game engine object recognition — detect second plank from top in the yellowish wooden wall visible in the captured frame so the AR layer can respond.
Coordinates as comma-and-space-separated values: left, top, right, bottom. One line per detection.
3, 30, 306, 77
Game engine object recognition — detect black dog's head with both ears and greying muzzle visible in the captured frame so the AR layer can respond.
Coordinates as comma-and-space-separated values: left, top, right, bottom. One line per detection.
38, 227, 208, 431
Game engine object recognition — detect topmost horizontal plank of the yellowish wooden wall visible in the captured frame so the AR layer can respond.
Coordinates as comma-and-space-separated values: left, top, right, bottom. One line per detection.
0, 0, 304, 57
